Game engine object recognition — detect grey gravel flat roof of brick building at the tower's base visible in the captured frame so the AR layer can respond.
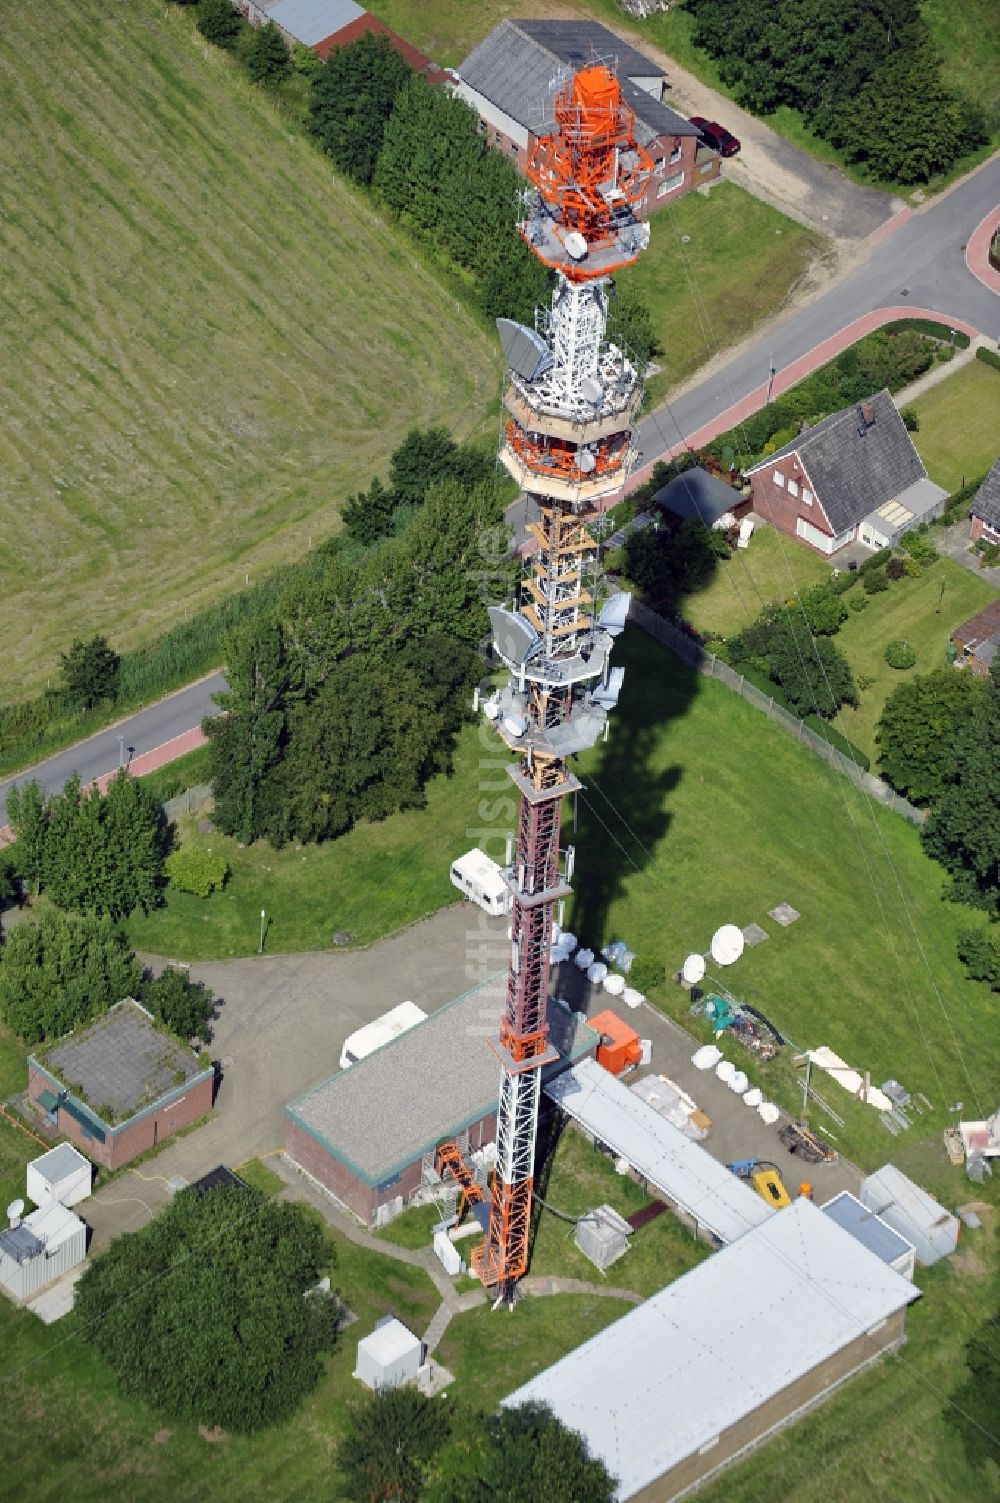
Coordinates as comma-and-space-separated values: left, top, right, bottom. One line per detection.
286, 972, 598, 1184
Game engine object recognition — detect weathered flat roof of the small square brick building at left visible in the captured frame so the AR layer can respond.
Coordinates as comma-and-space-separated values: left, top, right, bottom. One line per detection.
43, 998, 205, 1121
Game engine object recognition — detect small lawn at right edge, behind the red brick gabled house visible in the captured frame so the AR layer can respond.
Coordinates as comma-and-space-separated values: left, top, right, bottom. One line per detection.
913, 361, 1000, 491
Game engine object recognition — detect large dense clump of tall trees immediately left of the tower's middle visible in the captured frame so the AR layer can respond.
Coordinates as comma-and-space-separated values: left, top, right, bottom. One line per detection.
206, 434, 513, 846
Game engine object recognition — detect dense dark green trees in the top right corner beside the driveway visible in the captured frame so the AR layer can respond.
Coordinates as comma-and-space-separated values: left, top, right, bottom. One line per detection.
686, 0, 988, 183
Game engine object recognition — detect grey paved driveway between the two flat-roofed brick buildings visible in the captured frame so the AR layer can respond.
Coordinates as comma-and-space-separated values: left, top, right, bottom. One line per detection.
83, 903, 507, 1252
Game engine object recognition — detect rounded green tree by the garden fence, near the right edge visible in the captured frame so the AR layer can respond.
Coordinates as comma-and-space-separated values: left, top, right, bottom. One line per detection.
875, 667, 985, 804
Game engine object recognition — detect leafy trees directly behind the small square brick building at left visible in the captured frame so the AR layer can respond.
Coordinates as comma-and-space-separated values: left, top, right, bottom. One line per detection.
0, 909, 217, 1045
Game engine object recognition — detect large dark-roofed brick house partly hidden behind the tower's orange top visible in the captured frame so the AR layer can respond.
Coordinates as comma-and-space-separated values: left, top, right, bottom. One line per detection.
454, 21, 709, 215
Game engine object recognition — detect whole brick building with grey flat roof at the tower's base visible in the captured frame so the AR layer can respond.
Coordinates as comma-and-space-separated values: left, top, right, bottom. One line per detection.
284, 972, 598, 1223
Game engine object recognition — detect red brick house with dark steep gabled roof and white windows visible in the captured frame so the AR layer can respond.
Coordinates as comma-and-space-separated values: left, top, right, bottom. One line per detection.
746, 391, 947, 555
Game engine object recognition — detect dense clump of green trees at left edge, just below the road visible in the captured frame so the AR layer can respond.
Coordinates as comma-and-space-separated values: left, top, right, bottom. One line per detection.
8, 768, 168, 918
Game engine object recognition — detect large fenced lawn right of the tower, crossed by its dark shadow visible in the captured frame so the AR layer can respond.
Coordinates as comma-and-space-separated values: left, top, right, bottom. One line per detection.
567, 628, 1000, 1166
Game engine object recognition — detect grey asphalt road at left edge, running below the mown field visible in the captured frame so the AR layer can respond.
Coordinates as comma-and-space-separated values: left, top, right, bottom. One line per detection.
0, 673, 226, 827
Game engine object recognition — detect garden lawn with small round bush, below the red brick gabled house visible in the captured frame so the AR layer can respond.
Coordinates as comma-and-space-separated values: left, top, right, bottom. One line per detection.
833, 556, 1000, 757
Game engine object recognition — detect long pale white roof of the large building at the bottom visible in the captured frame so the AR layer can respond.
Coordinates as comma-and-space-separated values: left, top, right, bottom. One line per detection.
504, 1199, 919, 1500
